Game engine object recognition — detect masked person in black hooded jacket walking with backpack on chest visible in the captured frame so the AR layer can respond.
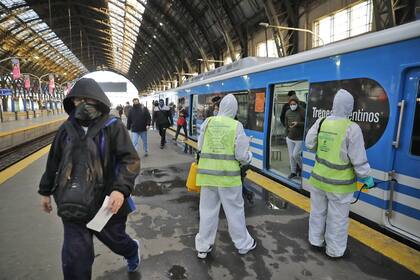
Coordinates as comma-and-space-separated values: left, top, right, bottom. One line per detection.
38, 78, 140, 279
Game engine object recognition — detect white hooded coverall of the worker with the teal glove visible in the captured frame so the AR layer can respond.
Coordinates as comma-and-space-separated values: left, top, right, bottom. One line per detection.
305, 89, 370, 257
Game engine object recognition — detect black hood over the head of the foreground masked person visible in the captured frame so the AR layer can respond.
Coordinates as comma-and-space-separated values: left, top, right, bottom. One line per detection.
63, 78, 111, 115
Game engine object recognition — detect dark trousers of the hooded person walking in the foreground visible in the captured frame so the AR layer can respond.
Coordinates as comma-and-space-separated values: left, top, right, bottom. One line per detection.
61, 219, 137, 280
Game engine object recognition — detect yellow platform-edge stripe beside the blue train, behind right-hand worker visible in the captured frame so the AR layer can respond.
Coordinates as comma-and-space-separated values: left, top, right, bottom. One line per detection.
246, 170, 420, 275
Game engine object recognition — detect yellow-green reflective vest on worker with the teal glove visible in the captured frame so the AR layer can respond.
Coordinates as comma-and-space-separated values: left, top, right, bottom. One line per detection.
309, 119, 357, 193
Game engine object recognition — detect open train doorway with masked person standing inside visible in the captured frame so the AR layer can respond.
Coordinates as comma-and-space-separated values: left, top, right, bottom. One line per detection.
269, 81, 309, 179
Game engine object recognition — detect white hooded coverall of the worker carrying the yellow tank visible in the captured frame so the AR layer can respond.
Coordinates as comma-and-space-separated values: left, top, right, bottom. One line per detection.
195, 94, 255, 254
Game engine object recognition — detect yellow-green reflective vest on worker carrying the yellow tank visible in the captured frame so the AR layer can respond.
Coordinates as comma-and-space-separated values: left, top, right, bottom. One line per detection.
197, 116, 242, 187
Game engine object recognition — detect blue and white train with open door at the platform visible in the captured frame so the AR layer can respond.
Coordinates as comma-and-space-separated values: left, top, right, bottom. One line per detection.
142, 21, 420, 244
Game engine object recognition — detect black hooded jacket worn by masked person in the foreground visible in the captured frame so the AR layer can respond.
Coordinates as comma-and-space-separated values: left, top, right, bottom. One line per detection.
38, 79, 140, 221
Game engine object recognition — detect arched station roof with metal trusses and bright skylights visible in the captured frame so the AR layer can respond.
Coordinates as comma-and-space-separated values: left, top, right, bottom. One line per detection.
0, 0, 288, 90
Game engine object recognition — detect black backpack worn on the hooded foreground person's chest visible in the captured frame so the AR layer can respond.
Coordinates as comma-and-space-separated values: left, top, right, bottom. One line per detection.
53, 116, 116, 222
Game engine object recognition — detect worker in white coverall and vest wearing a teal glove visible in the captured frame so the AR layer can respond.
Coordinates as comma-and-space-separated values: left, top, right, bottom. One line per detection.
305, 89, 374, 258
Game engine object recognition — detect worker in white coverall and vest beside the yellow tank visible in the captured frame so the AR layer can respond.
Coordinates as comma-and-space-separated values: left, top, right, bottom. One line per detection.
195, 94, 256, 259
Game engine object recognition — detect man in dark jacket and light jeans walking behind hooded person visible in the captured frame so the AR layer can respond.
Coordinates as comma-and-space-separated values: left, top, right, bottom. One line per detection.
127, 98, 151, 157
